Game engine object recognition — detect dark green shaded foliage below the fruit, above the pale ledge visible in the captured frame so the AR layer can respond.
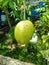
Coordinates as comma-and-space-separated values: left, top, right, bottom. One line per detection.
0, 43, 46, 65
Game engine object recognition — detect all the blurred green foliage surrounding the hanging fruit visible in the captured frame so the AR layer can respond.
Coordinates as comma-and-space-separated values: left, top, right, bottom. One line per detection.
0, 0, 49, 65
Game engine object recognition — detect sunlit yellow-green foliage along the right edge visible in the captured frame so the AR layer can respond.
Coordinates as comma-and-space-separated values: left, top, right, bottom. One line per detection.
35, 2, 49, 61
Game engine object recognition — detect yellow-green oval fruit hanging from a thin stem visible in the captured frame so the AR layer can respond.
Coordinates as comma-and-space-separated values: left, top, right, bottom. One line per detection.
14, 20, 34, 45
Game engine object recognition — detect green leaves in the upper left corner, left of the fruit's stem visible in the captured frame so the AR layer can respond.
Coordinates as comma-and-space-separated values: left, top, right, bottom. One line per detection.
0, 0, 23, 22
